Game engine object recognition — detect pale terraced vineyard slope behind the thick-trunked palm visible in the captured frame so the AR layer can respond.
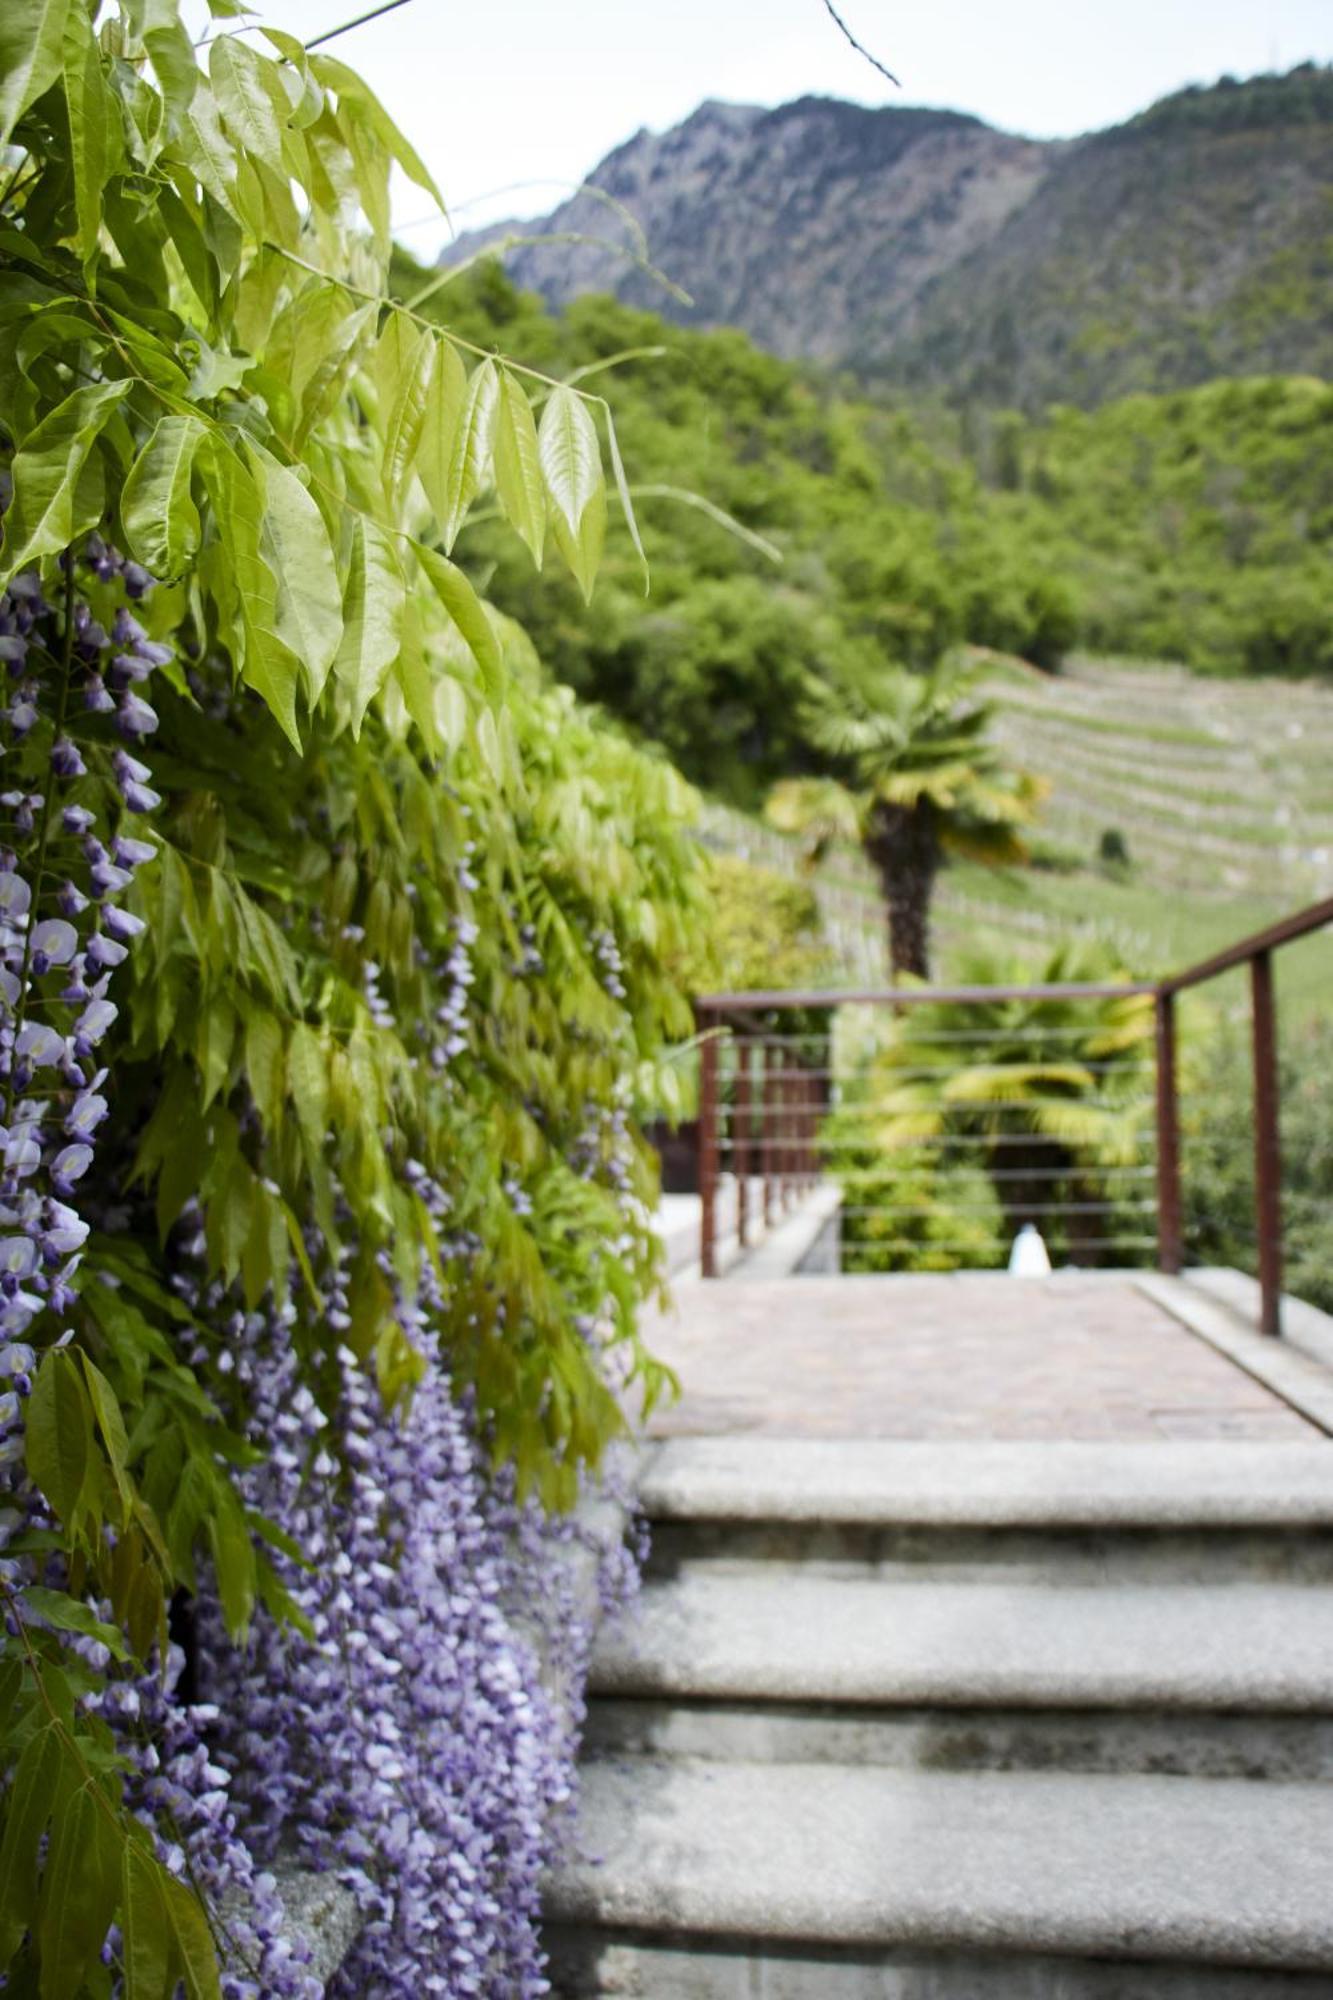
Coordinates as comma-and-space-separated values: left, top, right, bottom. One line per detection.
709, 660, 1333, 1012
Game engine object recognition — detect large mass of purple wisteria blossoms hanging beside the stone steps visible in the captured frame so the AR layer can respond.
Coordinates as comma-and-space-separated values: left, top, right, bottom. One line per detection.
197, 1288, 622, 2000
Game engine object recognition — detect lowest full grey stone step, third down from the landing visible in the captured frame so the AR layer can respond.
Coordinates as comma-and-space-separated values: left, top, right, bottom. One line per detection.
546, 1760, 1333, 1976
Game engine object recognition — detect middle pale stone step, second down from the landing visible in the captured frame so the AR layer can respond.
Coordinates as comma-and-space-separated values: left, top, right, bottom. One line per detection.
590, 1564, 1333, 1716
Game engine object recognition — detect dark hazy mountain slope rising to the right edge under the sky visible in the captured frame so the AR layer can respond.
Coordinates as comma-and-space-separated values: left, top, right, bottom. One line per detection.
880, 64, 1333, 410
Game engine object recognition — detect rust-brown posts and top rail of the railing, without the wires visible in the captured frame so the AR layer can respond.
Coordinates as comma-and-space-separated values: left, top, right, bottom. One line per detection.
695, 896, 1333, 1334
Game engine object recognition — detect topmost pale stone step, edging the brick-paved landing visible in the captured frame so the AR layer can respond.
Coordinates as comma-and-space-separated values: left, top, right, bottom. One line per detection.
640, 1438, 1333, 1584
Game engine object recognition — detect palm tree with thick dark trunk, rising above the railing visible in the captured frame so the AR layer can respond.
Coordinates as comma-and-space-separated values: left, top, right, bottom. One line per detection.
767, 656, 1041, 980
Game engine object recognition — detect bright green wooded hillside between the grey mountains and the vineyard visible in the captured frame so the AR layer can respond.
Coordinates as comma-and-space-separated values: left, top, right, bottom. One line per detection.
396, 262, 1333, 804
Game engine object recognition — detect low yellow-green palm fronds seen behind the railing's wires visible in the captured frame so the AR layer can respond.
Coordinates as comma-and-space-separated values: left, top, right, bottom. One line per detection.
865, 944, 1153, 1264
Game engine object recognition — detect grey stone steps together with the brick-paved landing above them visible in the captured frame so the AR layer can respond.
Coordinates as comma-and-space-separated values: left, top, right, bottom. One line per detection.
548, 1274, 1333, 2000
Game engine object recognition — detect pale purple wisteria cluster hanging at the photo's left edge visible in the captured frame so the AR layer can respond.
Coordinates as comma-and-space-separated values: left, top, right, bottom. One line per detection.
0, 536, 172, 1464
